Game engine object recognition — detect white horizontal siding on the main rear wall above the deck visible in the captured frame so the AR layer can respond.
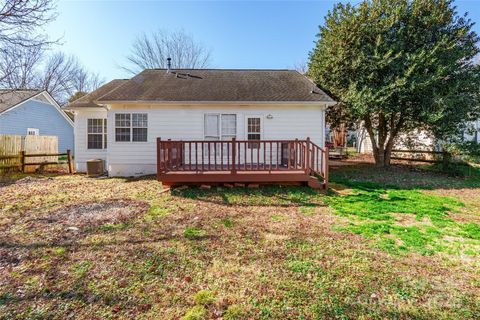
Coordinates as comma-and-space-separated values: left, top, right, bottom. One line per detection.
102, 104, 325, 176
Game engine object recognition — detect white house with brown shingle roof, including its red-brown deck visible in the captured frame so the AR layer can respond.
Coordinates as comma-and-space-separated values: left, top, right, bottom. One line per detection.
68, 69, 335, 188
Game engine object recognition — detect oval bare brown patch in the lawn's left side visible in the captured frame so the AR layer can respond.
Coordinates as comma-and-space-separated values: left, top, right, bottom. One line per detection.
46, 200, 148, 228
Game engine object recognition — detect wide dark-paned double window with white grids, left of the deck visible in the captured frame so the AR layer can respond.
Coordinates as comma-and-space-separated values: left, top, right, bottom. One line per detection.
115, 113, 148, 142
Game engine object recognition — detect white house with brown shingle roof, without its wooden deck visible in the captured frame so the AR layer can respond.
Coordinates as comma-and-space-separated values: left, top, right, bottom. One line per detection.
67, 69, 335, 185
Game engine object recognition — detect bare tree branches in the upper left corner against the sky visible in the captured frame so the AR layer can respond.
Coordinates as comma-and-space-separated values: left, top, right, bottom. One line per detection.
0, 0, 56, 86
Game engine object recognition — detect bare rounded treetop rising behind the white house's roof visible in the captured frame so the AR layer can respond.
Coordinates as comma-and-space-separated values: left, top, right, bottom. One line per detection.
122, 30, 211, 74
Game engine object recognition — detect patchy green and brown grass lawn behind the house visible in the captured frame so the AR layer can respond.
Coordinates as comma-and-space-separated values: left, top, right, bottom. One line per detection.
0, 166, 480, 319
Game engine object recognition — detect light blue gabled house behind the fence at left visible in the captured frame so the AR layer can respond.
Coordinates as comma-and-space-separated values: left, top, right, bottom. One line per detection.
0, 89, 74, 152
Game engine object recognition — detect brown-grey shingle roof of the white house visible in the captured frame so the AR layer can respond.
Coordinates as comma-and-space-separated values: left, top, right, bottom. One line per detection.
94, 69, 333, 104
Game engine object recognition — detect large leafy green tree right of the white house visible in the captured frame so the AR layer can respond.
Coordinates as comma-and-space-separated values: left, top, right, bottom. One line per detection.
309, 0, 480, 166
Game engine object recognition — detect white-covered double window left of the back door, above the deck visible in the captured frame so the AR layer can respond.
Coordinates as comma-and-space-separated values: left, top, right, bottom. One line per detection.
205, 114, 237, 140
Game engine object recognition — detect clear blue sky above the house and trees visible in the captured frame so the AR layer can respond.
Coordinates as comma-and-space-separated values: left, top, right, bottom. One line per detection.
46, 0, 480, 81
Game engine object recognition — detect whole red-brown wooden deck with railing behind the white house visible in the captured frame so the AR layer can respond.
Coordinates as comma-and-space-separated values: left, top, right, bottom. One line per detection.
157, 138, 328, 188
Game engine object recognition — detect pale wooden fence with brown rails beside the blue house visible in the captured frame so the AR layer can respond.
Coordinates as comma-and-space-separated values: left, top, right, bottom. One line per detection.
0, 135, 74, 173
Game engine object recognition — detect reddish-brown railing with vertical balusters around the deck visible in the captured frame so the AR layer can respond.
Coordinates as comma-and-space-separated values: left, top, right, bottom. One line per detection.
157, 138, 328, 185
